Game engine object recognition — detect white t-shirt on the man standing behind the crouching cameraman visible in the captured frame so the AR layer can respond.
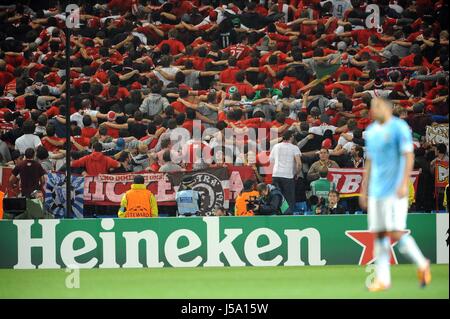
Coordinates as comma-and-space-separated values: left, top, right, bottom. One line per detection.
269, 142, 301, 178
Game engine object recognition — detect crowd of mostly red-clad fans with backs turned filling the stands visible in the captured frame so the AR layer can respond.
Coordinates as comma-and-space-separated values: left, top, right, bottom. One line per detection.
0, 0, 449, 218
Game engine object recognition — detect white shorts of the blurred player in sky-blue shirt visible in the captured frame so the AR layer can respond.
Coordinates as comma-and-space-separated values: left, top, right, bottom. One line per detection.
367, 195, 408, 232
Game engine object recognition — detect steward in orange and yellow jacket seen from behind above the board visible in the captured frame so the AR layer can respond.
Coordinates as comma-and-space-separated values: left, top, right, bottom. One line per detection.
118, 175, 158, 218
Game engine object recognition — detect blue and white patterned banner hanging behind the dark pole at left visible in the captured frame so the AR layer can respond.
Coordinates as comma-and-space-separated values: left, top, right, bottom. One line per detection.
45, 173, 84, 218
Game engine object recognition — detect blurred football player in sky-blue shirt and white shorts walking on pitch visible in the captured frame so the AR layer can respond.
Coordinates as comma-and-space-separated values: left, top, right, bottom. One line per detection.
359, 98, 431, 291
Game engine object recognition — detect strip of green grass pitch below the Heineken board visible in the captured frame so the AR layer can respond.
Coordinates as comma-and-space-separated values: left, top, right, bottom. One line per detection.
0, 265, 449, 299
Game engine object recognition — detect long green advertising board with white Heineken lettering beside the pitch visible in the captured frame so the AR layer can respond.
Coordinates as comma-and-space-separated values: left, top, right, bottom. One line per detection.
0, 214, 448, 269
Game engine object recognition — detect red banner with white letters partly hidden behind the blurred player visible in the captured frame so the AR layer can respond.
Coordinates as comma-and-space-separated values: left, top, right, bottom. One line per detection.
328, 168, 420, 198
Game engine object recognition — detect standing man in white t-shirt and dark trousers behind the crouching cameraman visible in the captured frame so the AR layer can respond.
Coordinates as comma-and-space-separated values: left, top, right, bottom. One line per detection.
269, 131, 302, 212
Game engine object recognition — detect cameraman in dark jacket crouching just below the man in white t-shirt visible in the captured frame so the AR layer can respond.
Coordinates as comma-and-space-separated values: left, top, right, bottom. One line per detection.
254, 183, 292, 215
